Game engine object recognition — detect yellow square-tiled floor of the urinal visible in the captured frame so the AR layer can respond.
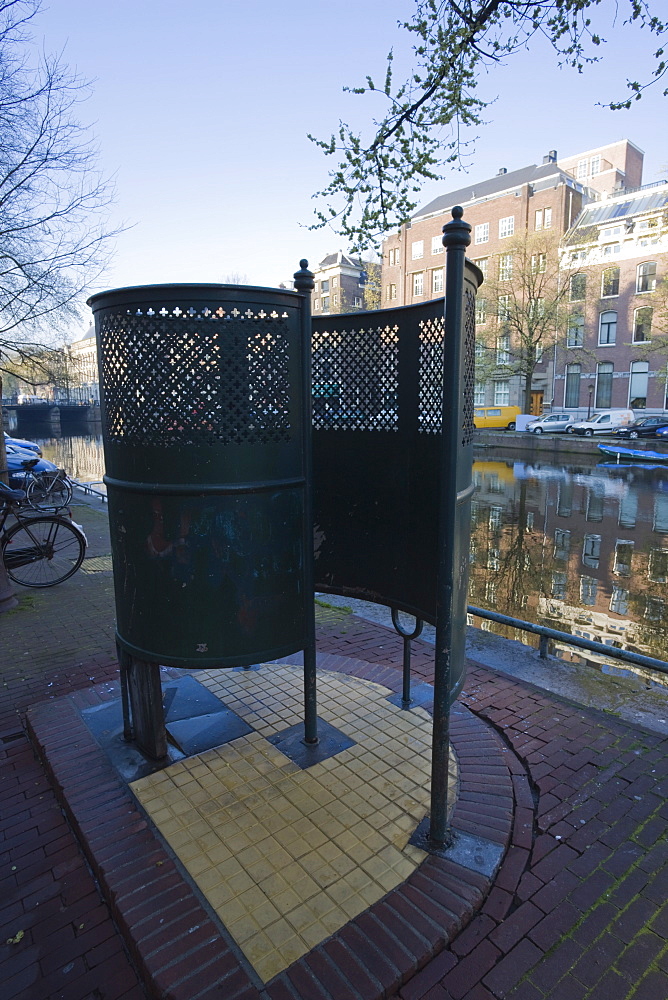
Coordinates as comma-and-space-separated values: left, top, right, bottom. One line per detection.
131, 665, 457, 983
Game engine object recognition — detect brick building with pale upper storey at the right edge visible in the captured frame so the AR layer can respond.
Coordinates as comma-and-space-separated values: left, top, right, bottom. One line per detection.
554, 182, 668, 412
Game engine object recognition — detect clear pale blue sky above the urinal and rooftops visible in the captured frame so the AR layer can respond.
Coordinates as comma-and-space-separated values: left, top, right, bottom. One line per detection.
33, 0, 668, 336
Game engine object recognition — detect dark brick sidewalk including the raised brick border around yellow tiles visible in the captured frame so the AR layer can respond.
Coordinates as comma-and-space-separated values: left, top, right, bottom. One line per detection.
0, 506, 668, 1000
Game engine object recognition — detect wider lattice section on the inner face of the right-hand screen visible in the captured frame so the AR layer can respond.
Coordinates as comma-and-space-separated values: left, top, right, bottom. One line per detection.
312, 324, 399, 431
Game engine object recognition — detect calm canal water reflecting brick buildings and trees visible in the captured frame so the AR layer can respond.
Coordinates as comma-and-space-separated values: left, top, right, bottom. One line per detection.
32, 434, 668, 673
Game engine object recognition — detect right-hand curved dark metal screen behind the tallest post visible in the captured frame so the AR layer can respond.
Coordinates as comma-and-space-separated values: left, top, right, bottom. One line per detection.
312, 264, 478, 704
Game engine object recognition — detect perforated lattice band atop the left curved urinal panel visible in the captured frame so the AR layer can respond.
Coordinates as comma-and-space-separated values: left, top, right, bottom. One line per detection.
100, 306, 292, 445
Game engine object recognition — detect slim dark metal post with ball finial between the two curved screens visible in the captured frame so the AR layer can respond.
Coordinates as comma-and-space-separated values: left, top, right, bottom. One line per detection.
294, 260, 318, 744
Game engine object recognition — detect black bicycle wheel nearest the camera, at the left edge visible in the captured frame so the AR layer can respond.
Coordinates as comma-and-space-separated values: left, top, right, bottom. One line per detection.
2, 514, 86, 587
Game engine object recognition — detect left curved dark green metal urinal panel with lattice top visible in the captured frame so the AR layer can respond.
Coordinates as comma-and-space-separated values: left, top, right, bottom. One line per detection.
89, 278, 313, 752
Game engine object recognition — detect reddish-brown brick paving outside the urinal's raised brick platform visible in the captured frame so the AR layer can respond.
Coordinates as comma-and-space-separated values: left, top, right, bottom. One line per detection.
0, 508, 668, 1000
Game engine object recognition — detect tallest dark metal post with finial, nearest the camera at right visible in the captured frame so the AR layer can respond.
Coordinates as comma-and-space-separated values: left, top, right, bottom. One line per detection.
429, 205, 471, 850
